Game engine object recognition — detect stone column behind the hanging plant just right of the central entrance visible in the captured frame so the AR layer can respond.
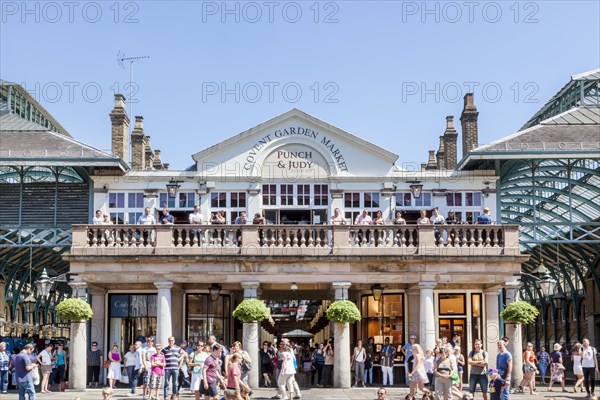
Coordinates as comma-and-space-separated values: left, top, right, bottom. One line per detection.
332, 282, 351, 389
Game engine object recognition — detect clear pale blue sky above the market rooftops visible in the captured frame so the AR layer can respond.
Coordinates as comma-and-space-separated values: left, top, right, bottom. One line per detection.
0, 0, 600, 169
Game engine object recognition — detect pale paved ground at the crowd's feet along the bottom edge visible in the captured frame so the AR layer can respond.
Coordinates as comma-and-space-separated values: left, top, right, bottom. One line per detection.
0, 387, 585, 400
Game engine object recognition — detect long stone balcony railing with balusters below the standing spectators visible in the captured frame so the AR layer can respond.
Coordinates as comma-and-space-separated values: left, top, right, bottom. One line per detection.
71, 225, 518, 255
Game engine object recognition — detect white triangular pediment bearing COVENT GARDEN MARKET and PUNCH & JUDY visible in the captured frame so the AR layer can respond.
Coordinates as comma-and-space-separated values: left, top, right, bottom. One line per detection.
192, 109, 398, 178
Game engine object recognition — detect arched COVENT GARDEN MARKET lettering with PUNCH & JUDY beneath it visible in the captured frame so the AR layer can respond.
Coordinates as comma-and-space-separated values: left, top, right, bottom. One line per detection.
244, 126, 348, 172
